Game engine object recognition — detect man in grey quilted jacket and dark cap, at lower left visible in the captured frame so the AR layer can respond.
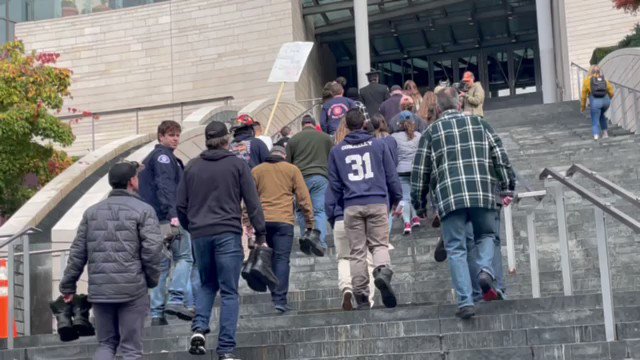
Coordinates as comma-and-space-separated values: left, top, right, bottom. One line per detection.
60, 162, 167, 360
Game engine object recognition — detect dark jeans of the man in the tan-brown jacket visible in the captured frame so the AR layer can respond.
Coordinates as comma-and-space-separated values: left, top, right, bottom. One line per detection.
267, 222, 293, 305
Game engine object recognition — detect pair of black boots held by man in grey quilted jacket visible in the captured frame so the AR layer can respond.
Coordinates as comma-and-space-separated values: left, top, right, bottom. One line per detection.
49, 295, 96, 342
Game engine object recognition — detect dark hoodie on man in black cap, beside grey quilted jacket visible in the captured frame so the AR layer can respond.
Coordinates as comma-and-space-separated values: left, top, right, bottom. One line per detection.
177, 148, 266, 239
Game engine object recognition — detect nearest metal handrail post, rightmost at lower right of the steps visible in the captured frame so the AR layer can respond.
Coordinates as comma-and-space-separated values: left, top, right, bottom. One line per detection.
595, 207, 616, 341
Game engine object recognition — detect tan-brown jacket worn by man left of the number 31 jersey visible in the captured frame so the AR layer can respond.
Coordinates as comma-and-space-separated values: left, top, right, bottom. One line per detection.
251, 159, 315, 227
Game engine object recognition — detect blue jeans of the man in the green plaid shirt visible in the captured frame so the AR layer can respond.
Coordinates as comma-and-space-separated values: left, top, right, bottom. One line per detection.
442, 208, 495, 307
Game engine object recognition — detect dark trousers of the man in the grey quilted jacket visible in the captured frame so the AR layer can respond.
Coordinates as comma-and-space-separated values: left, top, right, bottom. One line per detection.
93, 295, 149, 360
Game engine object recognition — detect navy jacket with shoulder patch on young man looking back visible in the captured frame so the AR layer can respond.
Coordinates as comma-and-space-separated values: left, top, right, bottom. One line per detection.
138, 144, 184, 221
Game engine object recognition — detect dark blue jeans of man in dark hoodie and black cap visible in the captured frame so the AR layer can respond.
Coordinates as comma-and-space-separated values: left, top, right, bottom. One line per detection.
191, 233, 244, 354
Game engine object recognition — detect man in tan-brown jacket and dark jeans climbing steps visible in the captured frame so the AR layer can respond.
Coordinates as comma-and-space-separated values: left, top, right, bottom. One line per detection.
251, 145, 314, 313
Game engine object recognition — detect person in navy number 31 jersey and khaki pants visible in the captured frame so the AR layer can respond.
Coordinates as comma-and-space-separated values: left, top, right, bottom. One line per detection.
329, 110, 402, 309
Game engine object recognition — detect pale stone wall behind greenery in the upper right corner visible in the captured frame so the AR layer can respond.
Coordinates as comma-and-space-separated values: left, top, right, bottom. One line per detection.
564, 0, 640, 99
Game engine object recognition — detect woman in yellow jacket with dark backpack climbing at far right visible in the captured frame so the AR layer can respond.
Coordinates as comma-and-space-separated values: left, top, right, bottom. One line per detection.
580, 66, 613, 140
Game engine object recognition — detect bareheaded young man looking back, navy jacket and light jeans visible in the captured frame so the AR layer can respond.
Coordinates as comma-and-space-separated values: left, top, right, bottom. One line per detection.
140, 120, 194, 326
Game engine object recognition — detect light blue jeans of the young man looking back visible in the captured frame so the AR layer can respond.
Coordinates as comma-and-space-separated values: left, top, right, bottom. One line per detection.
151, 228, 193, 317
